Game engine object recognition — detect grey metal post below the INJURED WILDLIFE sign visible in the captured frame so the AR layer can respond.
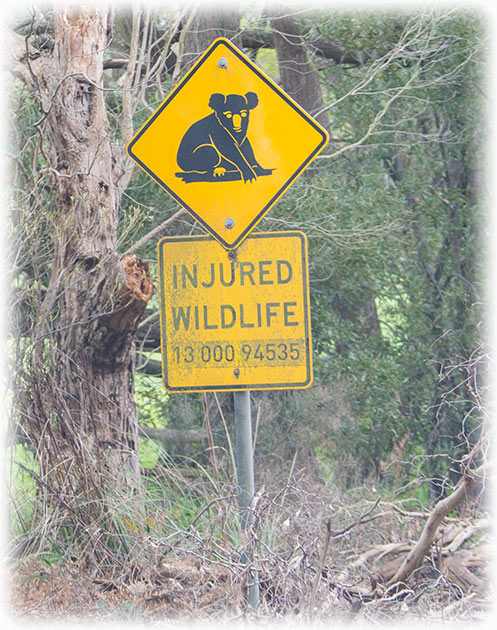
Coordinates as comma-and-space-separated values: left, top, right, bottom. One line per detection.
233, 391, 259, 611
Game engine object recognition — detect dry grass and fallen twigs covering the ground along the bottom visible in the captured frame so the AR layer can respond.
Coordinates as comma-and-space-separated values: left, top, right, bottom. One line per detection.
6, 471, 492, 625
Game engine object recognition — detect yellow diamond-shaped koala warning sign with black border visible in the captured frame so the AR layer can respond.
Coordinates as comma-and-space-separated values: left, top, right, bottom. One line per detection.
128, 38, 328, 249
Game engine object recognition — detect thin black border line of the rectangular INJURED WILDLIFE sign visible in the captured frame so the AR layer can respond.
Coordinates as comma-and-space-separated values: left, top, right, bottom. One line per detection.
157, 230, 313, 393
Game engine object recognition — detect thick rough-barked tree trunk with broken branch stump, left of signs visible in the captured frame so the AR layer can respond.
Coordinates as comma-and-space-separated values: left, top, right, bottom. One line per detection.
10, 6, 153, 556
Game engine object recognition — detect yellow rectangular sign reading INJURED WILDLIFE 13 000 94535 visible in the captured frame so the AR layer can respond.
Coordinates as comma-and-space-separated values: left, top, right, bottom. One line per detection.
158, 232, 312, 392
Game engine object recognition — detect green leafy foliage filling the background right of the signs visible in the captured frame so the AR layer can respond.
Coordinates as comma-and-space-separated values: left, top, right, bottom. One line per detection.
250, 12, 483, 483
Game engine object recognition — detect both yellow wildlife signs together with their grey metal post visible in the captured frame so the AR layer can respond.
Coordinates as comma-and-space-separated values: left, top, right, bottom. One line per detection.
128, 33, 328, 610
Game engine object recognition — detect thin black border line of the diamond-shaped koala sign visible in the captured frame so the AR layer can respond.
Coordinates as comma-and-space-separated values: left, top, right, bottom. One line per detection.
127, 38, 328, 249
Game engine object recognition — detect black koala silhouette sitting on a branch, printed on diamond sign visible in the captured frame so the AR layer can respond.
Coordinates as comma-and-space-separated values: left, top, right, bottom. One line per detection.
176, 92, 274, 183
